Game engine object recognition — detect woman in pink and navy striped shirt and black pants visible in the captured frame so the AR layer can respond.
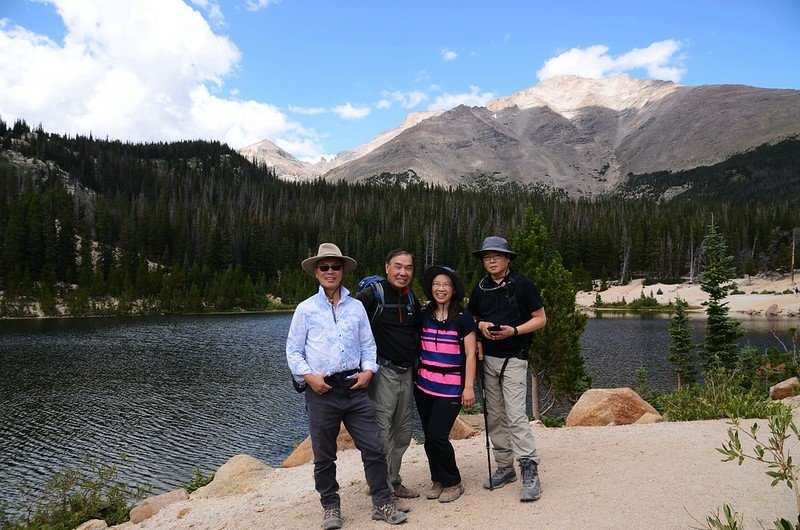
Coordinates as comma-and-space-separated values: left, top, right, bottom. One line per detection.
414, 265, 477, 502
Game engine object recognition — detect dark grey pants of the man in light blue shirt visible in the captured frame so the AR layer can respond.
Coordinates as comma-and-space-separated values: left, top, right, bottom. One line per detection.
306, 387, 391, 510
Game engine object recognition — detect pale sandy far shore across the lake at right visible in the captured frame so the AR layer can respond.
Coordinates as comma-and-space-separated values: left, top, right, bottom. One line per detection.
575, 273, 800, 318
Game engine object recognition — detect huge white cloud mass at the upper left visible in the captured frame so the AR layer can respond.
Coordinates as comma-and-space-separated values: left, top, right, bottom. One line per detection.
0, 0, 318, 152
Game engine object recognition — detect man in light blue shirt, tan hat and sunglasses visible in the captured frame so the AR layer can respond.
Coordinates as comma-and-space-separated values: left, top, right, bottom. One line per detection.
286, 243, 408, 530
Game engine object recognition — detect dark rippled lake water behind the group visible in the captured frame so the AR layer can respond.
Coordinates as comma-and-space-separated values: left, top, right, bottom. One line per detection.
0, 314, 797, 506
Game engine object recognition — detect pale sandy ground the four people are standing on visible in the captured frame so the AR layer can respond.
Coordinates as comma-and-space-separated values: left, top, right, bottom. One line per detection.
114, 417, 800, 530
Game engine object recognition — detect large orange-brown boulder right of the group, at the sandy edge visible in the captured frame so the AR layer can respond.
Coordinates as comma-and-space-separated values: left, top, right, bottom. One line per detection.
567, 388, 660, 427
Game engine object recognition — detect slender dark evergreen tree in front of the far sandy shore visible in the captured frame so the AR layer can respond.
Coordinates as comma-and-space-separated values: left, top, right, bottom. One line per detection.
700, 217, 743, 371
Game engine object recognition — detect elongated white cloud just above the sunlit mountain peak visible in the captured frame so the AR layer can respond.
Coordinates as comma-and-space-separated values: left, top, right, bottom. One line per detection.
536, 40, 686, 83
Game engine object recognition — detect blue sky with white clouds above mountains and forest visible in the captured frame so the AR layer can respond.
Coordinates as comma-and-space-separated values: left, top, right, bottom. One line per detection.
0, 0, 800, 162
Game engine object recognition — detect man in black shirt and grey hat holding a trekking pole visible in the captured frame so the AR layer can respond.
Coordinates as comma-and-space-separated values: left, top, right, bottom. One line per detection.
467, 236, 547, 501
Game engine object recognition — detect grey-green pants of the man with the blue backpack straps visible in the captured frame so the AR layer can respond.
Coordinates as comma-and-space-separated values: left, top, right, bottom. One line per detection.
369, 360, 414, 491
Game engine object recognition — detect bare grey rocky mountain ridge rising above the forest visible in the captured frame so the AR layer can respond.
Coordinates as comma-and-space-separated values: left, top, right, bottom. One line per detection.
239, 76, 800, 196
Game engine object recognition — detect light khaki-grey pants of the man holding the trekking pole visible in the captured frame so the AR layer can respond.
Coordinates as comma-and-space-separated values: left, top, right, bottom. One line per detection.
483, 356, 539, 467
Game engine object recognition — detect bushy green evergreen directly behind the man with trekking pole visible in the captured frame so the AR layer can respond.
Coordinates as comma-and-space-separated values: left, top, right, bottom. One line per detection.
511, 207, 591, 419
